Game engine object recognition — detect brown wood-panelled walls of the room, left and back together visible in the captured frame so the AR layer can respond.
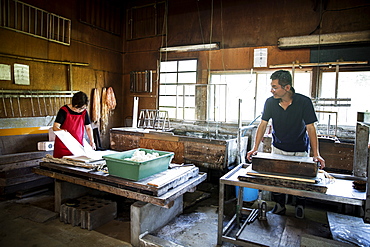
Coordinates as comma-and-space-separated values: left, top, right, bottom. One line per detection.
0, 0, 370, 151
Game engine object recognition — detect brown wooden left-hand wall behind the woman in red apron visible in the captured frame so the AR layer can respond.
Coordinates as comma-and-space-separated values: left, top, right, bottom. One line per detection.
0, 0, 124, 147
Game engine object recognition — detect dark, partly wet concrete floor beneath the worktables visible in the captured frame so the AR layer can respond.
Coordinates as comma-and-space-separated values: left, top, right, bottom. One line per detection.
0, 184, 364, 247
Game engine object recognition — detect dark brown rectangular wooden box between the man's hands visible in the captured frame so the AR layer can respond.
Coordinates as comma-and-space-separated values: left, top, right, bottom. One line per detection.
252, 153, 318, 178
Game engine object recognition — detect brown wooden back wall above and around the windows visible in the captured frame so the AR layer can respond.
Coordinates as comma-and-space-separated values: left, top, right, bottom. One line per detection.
123, 0, 370, 123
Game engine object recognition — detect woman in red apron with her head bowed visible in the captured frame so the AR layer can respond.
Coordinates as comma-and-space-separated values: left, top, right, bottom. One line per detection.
53, 92, 95, 158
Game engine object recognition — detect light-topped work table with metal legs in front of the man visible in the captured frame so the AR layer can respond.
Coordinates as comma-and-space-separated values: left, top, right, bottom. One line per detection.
217, 164, 366, 246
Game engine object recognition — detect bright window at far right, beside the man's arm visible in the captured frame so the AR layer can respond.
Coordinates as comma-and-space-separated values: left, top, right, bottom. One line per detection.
318, 71, 370, 126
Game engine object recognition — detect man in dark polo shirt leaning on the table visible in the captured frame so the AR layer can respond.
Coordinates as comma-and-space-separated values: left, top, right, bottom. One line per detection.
247, 70, 325, 218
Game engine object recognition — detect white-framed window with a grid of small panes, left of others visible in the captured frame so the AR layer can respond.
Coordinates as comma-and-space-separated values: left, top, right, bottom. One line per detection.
159, 60, 197, 120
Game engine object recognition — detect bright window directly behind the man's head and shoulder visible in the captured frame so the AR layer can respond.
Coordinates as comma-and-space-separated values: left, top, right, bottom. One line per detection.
208, 72, 311, 122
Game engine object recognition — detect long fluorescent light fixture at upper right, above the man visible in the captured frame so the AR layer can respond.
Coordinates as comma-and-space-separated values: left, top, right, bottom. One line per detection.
278, 31, 370, 49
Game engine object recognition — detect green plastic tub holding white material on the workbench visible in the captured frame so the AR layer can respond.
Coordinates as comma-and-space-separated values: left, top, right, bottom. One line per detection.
103, 148, 174, 181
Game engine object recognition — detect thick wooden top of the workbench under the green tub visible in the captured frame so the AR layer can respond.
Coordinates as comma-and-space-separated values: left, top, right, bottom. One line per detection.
33, 162, 207, 212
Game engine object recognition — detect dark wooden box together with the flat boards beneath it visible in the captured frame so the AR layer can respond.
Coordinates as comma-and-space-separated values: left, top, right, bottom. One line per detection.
239, 153, 327, 193
